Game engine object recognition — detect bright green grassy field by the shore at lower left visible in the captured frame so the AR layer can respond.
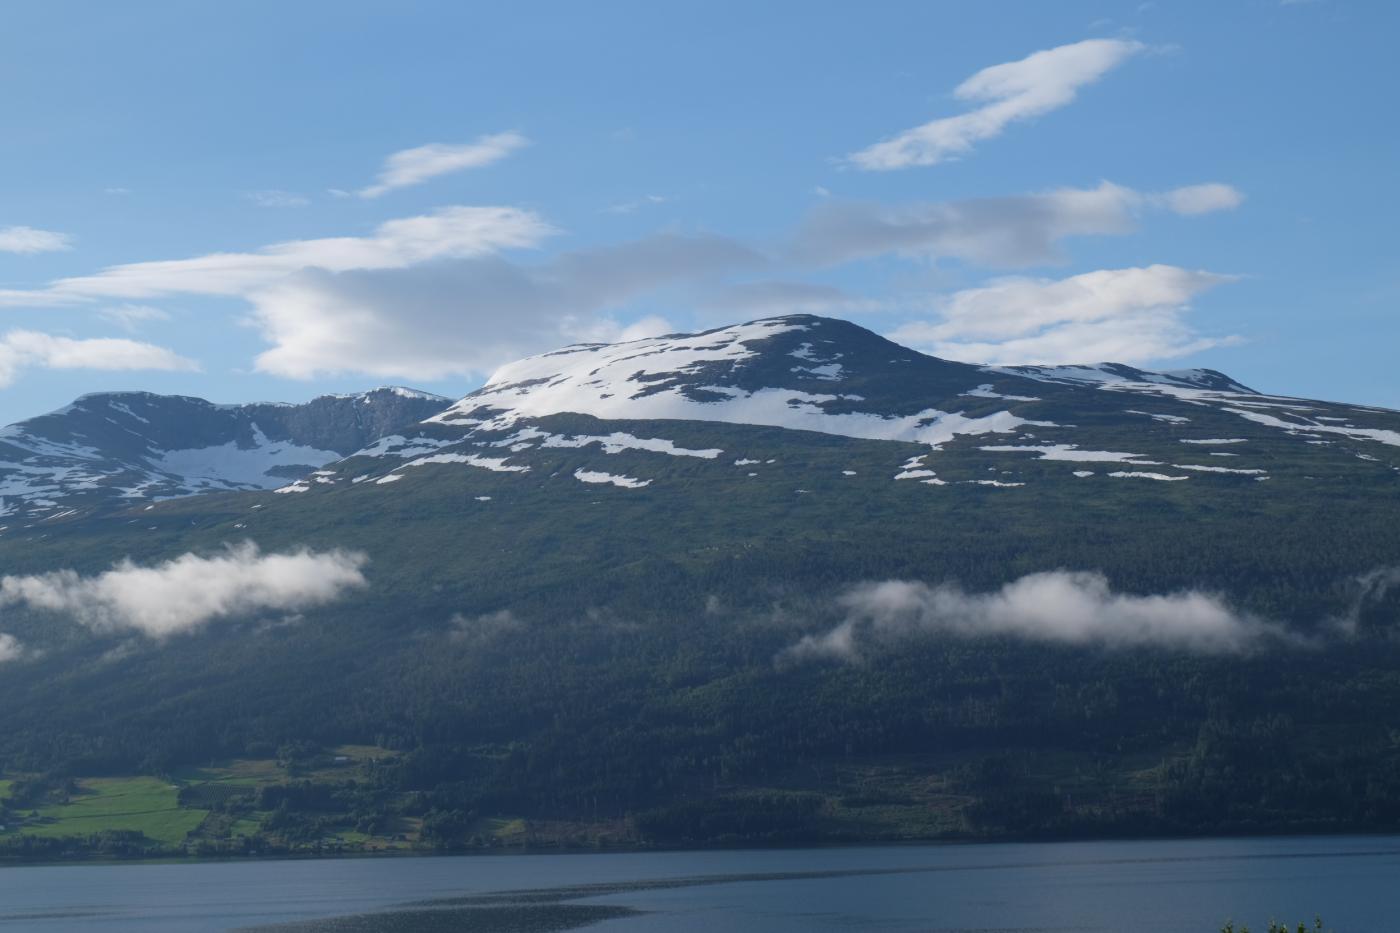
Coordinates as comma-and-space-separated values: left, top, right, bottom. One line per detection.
8, 778, 207, 846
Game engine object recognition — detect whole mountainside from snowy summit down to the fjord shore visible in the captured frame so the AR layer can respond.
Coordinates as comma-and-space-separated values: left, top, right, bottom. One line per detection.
0, 315, 1400, 856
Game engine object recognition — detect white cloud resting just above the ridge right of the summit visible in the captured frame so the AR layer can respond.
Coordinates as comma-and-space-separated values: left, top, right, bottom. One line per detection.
890, 265, 1232, 364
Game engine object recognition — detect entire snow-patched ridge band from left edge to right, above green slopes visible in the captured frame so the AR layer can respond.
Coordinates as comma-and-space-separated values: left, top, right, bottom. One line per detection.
8, 315, 1400, 516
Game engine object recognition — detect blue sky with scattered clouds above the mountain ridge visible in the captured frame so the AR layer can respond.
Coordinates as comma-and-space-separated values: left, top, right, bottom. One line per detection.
0, 0, 1400, 422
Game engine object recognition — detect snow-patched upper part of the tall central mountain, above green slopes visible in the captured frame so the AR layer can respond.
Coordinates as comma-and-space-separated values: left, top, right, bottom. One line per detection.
317, 315, 1400, 490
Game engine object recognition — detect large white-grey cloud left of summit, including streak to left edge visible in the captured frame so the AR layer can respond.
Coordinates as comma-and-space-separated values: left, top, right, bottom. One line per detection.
0, 207, 766, 378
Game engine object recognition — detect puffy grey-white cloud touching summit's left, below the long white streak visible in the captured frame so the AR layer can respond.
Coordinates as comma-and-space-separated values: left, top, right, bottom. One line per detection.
252, 234, 762, 378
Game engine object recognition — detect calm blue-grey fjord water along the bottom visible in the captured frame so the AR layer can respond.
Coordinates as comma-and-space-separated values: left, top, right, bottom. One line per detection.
0, 836, 1400, 933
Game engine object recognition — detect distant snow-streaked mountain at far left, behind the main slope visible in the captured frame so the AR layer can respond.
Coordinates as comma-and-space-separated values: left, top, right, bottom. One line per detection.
0, 387, 449, 516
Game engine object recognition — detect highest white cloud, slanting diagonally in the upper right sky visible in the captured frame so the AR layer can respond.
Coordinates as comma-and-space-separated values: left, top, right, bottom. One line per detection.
847, 39, 1147, 171
